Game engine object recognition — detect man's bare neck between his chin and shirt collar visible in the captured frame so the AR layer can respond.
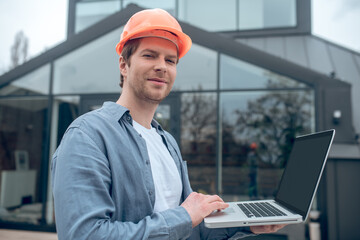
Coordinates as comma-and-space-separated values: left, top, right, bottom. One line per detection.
116, 92, 159, 129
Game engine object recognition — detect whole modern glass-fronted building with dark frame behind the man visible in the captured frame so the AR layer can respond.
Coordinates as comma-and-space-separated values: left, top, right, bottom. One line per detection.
0, 0, 360, 239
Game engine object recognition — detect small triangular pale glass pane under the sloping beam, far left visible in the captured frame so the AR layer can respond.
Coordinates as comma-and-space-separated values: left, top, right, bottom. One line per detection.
0, 64, 50, 96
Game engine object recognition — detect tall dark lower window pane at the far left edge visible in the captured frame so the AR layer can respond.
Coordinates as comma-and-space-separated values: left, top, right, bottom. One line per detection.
0, 97, 48, 224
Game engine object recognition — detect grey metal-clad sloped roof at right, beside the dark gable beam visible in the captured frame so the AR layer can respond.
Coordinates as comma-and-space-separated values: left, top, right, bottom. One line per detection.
237, 35, 360, 133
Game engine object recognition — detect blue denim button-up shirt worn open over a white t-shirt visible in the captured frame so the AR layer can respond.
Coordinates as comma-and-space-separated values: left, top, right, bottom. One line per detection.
51, 102, 250, 240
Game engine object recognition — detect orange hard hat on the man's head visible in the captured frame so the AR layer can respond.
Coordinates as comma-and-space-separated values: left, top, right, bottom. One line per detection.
116, 8, 192, 58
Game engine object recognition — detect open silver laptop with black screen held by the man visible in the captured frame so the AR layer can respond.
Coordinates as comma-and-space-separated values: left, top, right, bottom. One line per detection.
204, 129, 335, 228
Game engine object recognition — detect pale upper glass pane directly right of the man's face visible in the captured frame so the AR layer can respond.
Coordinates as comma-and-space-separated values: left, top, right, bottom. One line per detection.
173, 44, 217, 91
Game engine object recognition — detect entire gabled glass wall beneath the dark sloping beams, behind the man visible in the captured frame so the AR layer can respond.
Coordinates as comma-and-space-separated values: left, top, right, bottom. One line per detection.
0, 12, 315, 225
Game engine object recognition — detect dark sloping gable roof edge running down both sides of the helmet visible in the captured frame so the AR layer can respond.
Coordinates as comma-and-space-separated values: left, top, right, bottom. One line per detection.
0, 4, 349, 93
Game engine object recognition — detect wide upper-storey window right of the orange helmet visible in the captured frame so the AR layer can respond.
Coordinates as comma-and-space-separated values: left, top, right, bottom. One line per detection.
178, 0, 296, 31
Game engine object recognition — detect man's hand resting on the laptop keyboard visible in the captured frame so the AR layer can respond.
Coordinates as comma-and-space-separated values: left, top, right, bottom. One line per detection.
181, 192, 229, 227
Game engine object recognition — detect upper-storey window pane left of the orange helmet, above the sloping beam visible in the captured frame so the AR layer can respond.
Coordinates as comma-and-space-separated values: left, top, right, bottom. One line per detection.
75, 0, 120, 33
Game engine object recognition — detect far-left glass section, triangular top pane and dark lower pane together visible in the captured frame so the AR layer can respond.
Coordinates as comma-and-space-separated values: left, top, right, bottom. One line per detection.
0, 64, 50, 224
